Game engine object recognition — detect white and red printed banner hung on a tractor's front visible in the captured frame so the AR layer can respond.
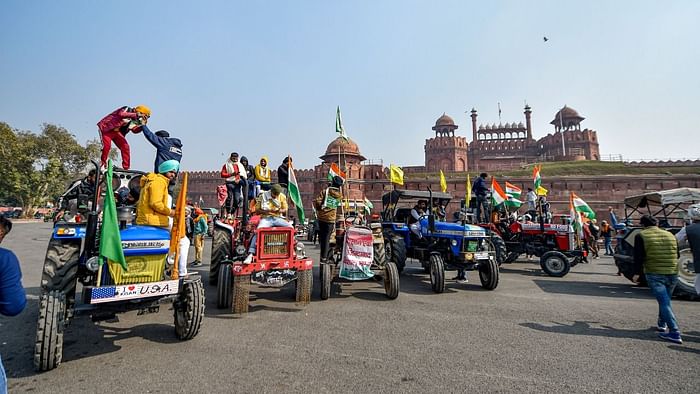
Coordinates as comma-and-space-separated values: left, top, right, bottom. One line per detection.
339, 227, 374, 280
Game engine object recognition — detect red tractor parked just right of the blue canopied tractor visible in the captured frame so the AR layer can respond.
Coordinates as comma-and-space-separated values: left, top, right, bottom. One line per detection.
479, 221, 588, 277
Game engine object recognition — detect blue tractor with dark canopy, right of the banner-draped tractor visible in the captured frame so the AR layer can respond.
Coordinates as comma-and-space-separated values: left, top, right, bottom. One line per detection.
382, 190, 499, 293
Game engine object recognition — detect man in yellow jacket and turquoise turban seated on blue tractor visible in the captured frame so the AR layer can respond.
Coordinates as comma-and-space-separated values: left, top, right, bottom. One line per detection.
136, 160, 190, 276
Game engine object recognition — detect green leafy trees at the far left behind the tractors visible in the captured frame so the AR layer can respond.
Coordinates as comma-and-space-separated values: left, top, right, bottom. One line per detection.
0, 122, 101, 215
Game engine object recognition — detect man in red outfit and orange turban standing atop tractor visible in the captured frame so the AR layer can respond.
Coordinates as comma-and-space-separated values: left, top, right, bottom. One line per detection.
97, 105, 151, 170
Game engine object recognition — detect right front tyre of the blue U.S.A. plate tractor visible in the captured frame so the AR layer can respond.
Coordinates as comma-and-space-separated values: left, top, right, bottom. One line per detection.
173, 278, 204, 341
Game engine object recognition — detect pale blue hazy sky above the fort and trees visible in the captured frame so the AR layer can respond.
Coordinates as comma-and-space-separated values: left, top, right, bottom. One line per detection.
0, 0, 700, 170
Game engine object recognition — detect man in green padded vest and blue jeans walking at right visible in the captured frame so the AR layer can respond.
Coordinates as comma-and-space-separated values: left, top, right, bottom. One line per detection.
633, 215, 683, 344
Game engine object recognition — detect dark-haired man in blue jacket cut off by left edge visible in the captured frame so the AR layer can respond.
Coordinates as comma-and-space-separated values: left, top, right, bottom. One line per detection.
0, 217, 27, 394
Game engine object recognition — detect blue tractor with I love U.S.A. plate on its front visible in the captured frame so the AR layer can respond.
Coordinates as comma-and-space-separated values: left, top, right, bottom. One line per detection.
34, 166, 204, 371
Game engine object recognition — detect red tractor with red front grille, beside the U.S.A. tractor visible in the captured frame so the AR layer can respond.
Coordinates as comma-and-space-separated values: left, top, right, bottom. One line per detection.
209, 188, 313, 313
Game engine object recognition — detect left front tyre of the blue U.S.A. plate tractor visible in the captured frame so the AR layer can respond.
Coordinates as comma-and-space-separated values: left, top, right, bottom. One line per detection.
34, 291, 66, 372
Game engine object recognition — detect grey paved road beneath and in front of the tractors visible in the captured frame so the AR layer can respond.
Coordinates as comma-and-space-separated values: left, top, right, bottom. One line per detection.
0, 223, 700, 393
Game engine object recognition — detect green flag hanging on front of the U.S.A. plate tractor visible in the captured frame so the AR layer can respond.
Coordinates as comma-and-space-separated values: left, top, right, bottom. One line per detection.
100, 159, 127, 271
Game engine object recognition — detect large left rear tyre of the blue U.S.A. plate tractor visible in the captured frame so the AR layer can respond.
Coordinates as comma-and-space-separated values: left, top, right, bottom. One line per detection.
41, 239, 80, 324
